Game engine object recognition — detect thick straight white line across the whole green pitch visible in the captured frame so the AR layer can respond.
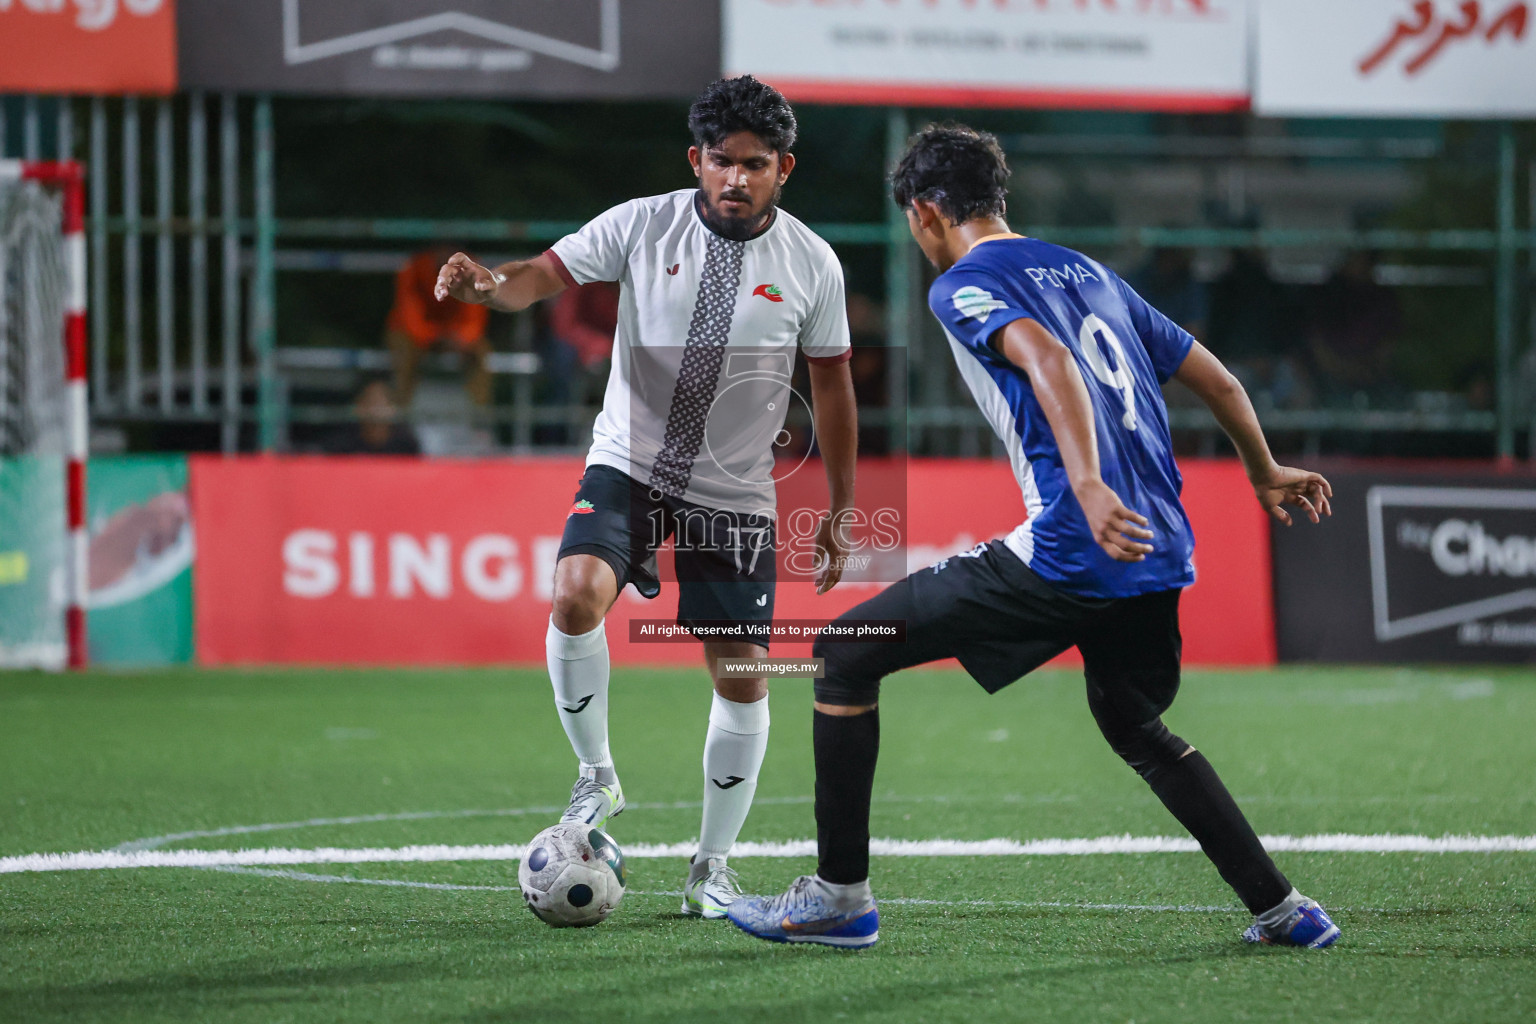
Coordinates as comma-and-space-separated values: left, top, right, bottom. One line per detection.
0, 834, 1536, 875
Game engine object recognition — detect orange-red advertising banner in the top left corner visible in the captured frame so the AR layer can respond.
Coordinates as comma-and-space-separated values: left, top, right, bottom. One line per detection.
0, 0, 177, 94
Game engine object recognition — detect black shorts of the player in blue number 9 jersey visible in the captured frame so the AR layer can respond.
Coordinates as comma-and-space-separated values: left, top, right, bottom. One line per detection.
816, 540, 1183, 725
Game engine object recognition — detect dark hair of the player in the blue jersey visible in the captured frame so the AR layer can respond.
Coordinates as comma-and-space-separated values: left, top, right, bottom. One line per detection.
891, 124, 1011, 224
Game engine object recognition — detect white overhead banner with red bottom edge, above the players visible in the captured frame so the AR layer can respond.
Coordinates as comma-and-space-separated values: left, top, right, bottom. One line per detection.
723, 0, 1250, 111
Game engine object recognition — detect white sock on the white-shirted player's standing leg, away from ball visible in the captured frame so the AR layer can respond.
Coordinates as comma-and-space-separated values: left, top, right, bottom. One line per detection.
699, 694, 768, 861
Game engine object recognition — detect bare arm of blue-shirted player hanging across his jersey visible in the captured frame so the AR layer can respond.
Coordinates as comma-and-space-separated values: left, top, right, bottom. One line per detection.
992, 319, 1152, 562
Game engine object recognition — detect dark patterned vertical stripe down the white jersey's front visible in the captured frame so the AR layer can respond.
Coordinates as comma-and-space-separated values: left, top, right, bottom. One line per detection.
651, 233, 746, 497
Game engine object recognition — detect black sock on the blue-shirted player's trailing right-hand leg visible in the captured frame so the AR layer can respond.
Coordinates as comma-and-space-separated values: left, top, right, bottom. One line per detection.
1146, 751, 1290, 913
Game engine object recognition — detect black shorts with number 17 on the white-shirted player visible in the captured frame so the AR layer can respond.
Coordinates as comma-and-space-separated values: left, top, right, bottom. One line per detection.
559, 465, 777, 646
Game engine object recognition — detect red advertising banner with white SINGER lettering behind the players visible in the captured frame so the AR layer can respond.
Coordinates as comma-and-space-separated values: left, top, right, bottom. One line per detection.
192, 457, 1275, 665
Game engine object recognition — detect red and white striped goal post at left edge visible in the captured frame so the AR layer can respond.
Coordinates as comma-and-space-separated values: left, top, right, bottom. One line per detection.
0, 160, 89, 668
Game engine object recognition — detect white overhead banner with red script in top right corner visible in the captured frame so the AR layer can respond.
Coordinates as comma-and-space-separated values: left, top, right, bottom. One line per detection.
1253, 0, 1536, 118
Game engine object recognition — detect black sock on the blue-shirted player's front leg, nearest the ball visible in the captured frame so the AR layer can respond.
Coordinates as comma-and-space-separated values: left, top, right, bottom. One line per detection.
811, 709, 880, 886
